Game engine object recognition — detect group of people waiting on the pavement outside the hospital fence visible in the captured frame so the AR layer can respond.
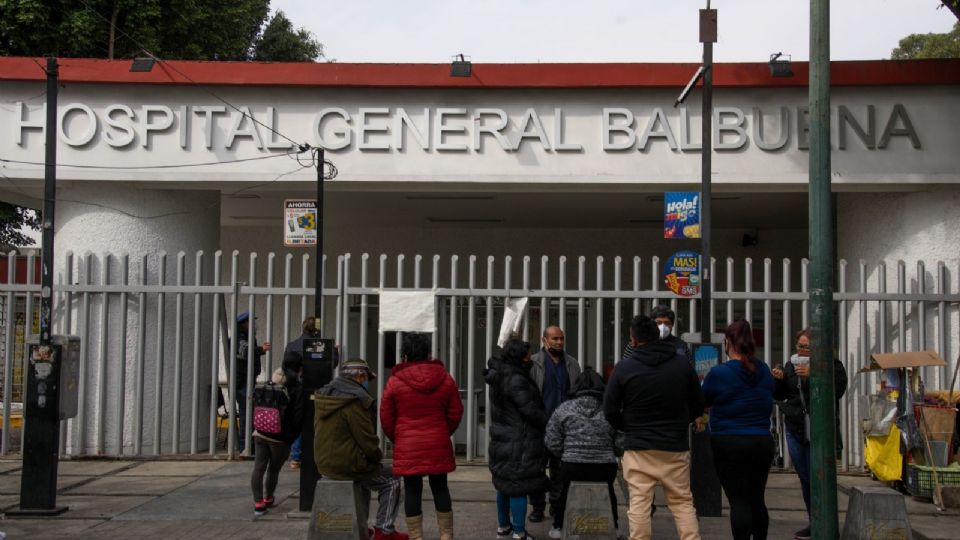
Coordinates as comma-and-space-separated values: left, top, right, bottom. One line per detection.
242, 306, 846, 540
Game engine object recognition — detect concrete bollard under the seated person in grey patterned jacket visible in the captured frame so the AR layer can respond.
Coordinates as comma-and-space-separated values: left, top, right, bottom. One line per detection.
563, 482, 617, 540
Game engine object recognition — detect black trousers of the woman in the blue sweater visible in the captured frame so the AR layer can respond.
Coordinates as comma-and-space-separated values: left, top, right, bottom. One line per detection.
710, 435, 773, 540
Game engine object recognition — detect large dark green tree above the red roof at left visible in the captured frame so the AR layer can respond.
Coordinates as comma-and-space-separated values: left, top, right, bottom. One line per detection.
0, 0, 278, 60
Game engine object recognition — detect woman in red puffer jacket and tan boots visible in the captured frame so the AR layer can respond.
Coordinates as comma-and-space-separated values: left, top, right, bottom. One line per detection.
380, 333, 463, 540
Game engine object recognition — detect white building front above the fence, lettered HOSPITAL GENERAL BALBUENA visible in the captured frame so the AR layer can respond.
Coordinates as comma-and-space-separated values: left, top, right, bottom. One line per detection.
0, 62, 960, 456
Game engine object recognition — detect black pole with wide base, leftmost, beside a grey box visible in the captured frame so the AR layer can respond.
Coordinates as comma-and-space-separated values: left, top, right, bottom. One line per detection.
14, 56, 67, 515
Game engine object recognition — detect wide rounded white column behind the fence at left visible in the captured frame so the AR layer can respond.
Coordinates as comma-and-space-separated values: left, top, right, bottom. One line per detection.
54, 182, 220, 455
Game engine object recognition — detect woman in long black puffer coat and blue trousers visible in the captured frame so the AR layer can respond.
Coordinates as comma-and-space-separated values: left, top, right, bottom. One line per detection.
484, 338, 549, 540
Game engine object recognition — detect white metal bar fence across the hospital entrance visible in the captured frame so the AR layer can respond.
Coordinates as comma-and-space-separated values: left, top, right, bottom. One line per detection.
0, 252, 960, 468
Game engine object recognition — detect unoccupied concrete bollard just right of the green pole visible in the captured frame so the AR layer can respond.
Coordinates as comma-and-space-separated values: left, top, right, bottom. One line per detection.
841, 486, 913, 540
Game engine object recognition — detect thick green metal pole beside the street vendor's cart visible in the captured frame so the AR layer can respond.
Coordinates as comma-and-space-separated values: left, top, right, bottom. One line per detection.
809, 0, 839, 538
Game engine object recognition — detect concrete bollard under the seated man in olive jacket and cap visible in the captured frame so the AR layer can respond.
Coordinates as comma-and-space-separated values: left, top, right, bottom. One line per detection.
307, 479, 370, 540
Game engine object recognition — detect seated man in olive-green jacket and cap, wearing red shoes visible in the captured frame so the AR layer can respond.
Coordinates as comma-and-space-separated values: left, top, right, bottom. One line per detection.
313, 358, 409, 540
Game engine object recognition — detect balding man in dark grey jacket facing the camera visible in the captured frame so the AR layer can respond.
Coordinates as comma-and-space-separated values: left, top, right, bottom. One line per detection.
530, 326, 580, 523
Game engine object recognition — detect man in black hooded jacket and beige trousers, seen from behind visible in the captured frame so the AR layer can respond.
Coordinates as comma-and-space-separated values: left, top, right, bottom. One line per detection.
603, 315, 703, 540
